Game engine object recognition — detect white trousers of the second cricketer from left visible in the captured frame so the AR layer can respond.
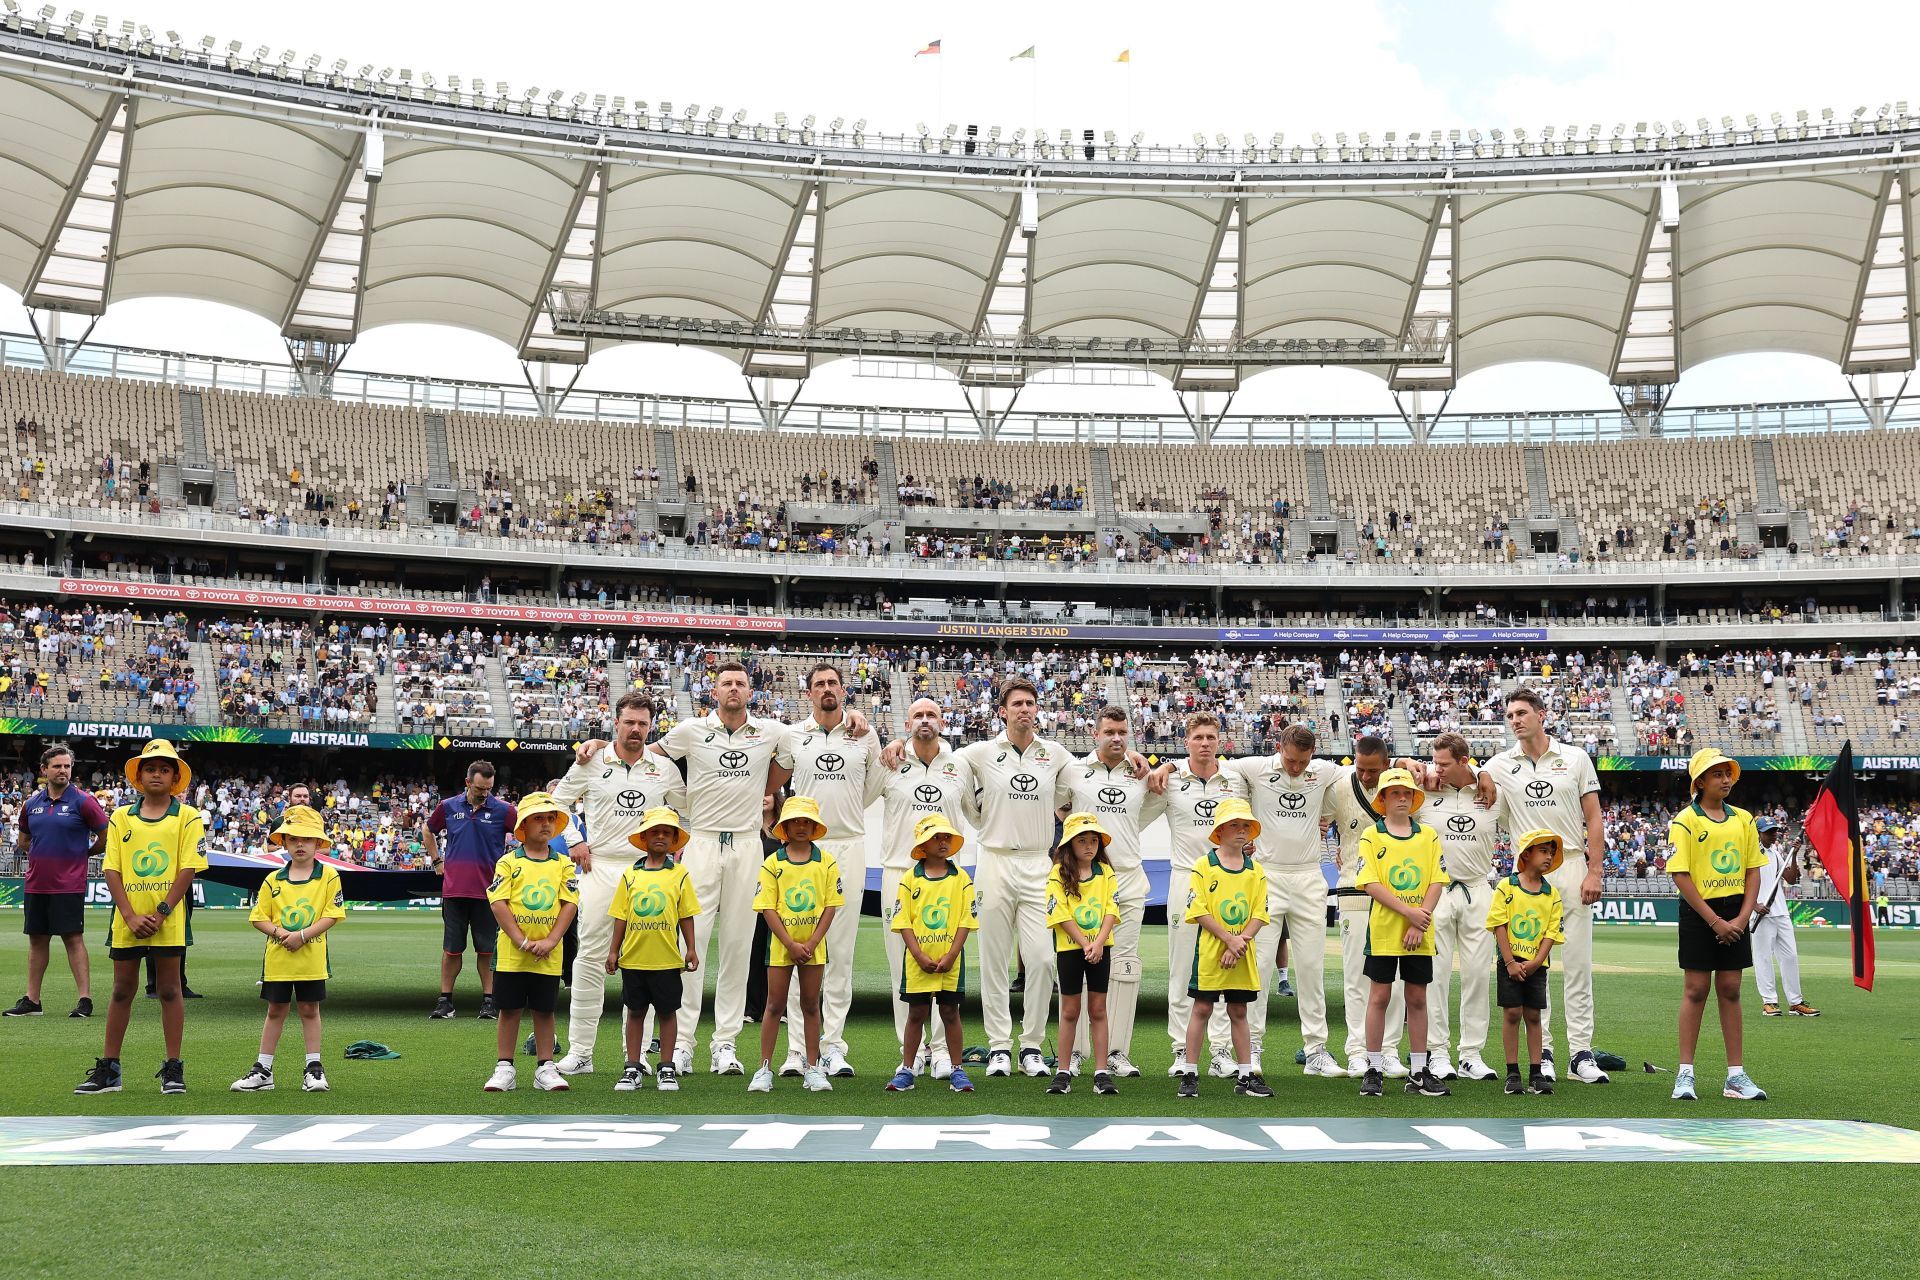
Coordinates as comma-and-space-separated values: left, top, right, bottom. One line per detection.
674, 831, 762, 1054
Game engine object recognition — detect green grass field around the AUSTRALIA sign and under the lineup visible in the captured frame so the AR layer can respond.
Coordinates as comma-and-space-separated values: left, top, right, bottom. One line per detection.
0, 912, 1920, 1276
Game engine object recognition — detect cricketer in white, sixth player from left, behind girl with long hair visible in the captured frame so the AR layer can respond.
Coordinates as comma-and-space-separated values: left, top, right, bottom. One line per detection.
1054, 706, 1167, 1077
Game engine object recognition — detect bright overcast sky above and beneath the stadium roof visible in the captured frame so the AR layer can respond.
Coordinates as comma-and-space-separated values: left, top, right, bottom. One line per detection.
0, 0, 1920, 413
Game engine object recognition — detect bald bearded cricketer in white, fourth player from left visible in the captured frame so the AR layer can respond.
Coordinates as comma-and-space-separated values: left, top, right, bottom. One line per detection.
879, 699, 979, 1080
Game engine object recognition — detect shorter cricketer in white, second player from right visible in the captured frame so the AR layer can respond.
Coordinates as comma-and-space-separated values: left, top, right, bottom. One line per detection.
1421, 733, 1511, 1080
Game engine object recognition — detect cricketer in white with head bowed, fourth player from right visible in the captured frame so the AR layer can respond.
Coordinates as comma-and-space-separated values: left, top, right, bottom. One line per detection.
1221, 725, 1357, 1079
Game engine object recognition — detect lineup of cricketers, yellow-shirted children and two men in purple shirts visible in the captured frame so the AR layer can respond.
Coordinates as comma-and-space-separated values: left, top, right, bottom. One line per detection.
21, 662, 1770, 1100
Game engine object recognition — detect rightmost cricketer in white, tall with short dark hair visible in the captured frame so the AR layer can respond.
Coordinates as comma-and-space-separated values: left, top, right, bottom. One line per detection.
1480, 689, 1607, 1084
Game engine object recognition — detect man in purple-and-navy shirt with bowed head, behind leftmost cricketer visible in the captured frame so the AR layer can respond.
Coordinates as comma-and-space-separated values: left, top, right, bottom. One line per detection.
422, 760, 518, 1021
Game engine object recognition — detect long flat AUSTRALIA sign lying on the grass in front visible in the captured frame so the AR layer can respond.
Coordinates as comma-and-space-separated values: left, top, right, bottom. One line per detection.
0, 1115, 1920, 1165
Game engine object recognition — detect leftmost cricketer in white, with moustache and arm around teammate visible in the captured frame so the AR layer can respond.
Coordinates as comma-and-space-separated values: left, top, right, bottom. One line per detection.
553, 689, 687, 1075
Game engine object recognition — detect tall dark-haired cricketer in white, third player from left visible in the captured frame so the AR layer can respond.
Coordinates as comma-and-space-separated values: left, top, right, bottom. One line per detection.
774, 662, 887, 1077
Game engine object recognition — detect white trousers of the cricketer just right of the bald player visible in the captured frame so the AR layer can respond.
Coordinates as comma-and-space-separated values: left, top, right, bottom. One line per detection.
973, 848, 1054, 1052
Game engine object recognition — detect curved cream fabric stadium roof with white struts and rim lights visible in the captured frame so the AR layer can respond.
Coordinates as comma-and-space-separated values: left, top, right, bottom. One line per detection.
0, 15, 1920, 390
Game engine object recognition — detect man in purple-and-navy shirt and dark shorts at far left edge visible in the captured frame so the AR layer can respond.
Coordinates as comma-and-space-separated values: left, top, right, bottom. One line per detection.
6, 743, 108, 1017
